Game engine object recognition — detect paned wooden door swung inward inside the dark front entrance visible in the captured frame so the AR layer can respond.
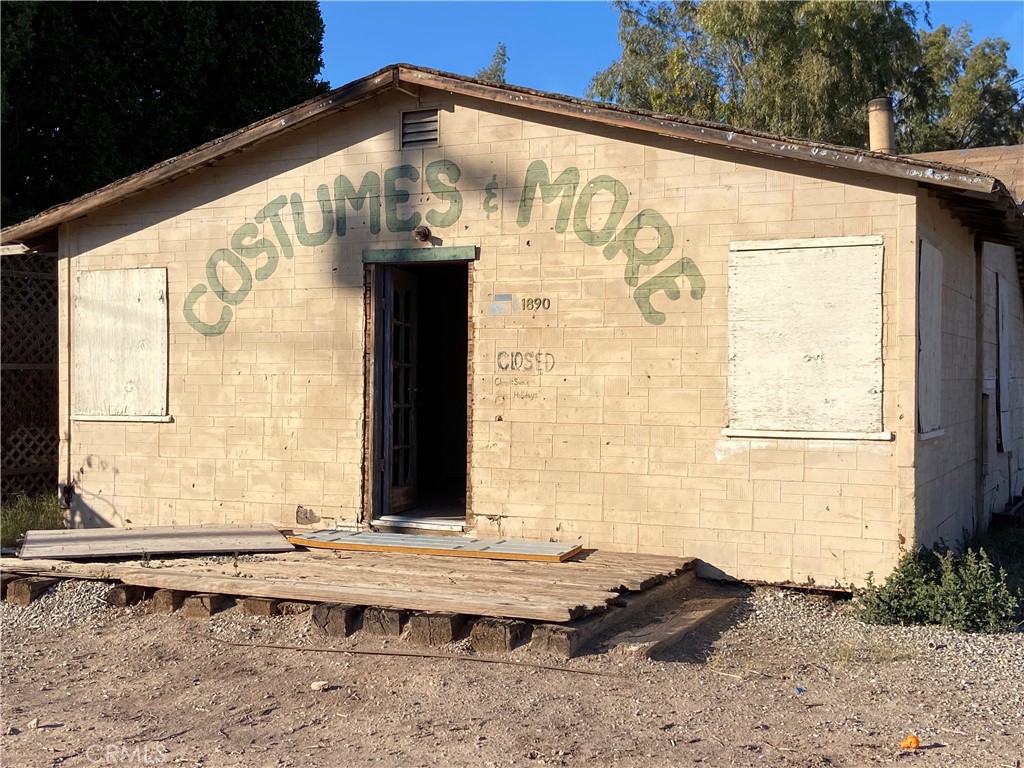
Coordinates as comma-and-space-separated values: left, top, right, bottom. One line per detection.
384, 267, 417, 514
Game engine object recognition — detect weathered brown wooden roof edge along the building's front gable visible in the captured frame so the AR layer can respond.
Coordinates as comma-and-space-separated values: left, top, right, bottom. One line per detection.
0, 63, 1024, 252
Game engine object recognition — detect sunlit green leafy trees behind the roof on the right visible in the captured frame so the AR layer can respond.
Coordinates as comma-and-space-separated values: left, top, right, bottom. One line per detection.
589, 0, 1022, 152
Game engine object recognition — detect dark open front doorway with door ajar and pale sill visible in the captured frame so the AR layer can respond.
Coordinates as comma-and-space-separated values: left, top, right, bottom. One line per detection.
373, 262, 468, 531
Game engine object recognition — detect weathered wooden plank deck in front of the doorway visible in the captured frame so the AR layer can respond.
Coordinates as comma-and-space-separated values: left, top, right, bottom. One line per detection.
0, 551, 694, 622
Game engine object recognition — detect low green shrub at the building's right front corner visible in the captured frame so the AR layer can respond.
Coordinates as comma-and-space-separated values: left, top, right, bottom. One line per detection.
857, 545, 1024, 633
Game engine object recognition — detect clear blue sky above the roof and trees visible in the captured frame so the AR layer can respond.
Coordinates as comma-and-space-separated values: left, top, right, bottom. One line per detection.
321, 0, 1024, 96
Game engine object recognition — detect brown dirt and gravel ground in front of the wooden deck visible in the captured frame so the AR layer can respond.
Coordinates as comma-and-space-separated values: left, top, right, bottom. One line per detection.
0, 582, 1024, 768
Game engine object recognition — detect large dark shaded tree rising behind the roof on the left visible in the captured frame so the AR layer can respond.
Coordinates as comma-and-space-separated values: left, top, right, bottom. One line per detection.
0, 2, 328, 225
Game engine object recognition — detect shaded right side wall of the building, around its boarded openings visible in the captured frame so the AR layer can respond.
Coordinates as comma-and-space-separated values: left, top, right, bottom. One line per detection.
915, 194, 1024, 546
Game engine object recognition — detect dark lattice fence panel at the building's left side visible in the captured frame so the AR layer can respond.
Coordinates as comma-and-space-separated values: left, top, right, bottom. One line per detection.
0, 254, 58, 499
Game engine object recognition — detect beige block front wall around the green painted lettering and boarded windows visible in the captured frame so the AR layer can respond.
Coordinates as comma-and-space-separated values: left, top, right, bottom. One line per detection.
61, 88, 918, 584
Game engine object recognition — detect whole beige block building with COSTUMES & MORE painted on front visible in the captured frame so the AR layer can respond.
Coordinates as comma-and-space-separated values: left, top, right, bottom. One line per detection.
3, 65, 1024, 585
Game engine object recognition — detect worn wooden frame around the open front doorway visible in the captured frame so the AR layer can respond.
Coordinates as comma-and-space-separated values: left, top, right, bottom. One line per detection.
358, 259, 479, 532
